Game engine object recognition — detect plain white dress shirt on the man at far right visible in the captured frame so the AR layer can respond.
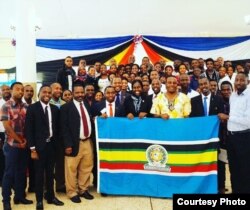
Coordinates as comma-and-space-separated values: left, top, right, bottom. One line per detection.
227, 88, 250, 131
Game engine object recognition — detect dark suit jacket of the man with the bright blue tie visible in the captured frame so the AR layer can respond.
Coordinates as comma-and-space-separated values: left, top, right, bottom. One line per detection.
189, 94, 224, 117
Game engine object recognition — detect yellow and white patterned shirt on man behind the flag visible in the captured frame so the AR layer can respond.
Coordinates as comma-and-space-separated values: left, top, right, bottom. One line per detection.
150, 93, 191, 118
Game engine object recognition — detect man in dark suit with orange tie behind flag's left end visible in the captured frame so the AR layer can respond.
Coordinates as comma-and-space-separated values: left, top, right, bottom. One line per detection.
93, 86, 125, 118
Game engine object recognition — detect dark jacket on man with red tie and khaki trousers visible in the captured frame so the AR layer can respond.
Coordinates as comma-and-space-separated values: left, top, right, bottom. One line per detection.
60, 101, 94, 157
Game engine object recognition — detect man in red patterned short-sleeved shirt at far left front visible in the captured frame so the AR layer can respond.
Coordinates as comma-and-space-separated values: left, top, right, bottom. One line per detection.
1, 82, 33, 210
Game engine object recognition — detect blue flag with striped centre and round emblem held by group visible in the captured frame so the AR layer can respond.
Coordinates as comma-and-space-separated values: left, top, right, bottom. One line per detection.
96, 116, 219, 197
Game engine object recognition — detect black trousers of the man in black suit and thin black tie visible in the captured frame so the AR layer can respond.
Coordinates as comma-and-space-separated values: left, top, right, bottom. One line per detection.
34, 142, 56, 202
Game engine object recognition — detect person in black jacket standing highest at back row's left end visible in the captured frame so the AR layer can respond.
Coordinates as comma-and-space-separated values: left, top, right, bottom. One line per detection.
56, 56, 76, 91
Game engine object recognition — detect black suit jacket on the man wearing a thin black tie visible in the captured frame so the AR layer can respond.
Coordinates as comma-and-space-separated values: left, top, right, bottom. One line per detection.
25, 101, 59, 151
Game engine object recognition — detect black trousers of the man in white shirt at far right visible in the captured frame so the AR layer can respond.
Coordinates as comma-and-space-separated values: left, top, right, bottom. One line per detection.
226, 132, 250, 194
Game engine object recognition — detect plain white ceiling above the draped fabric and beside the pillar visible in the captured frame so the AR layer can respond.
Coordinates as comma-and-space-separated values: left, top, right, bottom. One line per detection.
0, 0, 250, 38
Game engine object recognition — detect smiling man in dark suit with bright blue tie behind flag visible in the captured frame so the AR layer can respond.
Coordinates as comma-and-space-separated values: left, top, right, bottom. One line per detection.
189, 78, 223, 117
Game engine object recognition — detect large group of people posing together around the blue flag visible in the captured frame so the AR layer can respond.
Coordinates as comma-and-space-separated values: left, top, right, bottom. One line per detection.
0, 55, 250, 210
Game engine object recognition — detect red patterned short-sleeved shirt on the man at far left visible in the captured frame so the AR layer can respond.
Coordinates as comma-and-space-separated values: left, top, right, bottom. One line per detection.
0, 99, 28, 146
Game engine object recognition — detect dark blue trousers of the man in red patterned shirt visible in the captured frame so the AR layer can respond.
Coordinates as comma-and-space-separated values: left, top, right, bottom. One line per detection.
2, 143, 28, 203
